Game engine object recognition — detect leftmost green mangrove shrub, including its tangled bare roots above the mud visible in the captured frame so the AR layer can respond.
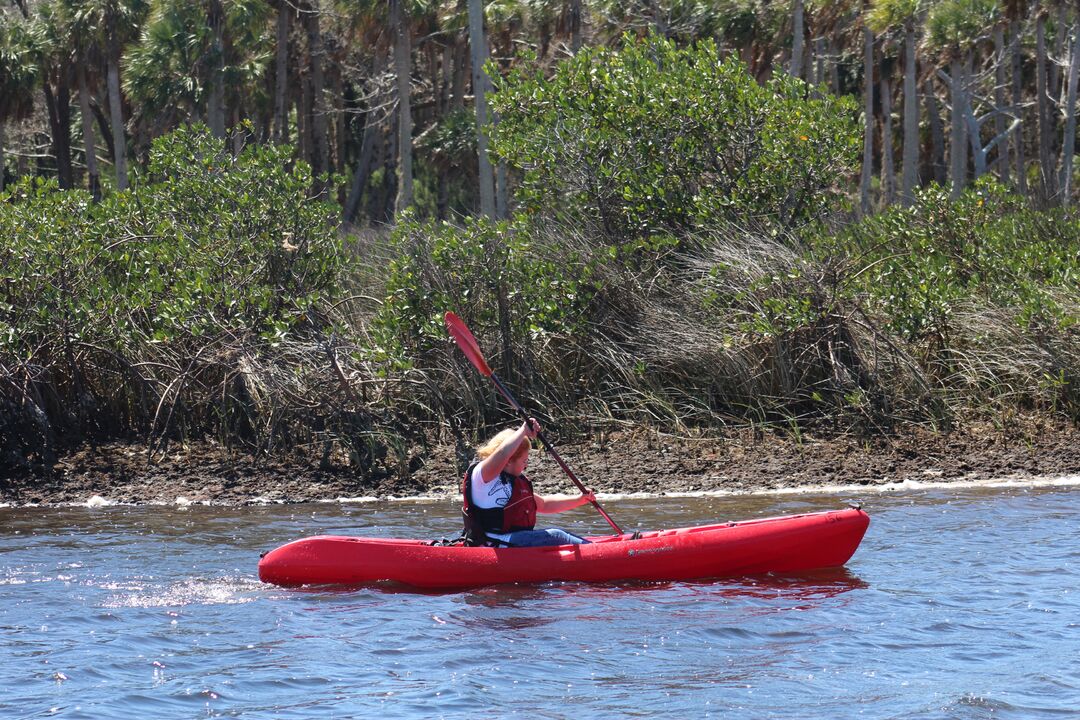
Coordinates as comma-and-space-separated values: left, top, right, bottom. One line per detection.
0, 128, 346, 468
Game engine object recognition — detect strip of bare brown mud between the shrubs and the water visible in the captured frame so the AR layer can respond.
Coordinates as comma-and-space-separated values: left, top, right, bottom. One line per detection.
0, 418, 1080, 505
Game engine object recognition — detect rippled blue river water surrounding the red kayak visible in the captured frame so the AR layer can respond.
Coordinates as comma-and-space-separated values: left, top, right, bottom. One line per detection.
0, 487, 1080, 720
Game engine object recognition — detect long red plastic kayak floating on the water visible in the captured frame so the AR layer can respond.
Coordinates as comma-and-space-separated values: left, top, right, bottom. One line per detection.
259, 508, 869, 588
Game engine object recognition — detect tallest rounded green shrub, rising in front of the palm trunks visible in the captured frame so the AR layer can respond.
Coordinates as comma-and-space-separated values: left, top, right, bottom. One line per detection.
492, 35, 859, 237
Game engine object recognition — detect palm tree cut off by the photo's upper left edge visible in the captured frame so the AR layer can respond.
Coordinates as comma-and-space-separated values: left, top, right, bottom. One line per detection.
0, 9, 39, 190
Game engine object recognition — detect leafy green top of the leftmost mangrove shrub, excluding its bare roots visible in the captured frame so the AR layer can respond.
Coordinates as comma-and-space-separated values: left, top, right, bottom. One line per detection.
0, 130, 345, 364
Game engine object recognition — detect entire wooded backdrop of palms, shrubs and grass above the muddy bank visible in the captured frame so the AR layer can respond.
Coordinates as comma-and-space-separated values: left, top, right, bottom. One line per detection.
0, 0, 1080, 490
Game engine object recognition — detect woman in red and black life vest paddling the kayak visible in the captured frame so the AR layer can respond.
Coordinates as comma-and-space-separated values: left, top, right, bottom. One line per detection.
461, 418, 596, 547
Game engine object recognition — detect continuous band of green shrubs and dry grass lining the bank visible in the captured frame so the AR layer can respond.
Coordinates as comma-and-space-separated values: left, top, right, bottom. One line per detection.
0, 18, 1080, 475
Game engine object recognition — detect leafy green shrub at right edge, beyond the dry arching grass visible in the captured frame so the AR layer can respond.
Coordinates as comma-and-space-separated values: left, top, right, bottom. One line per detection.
815, 181, 1080, 343
